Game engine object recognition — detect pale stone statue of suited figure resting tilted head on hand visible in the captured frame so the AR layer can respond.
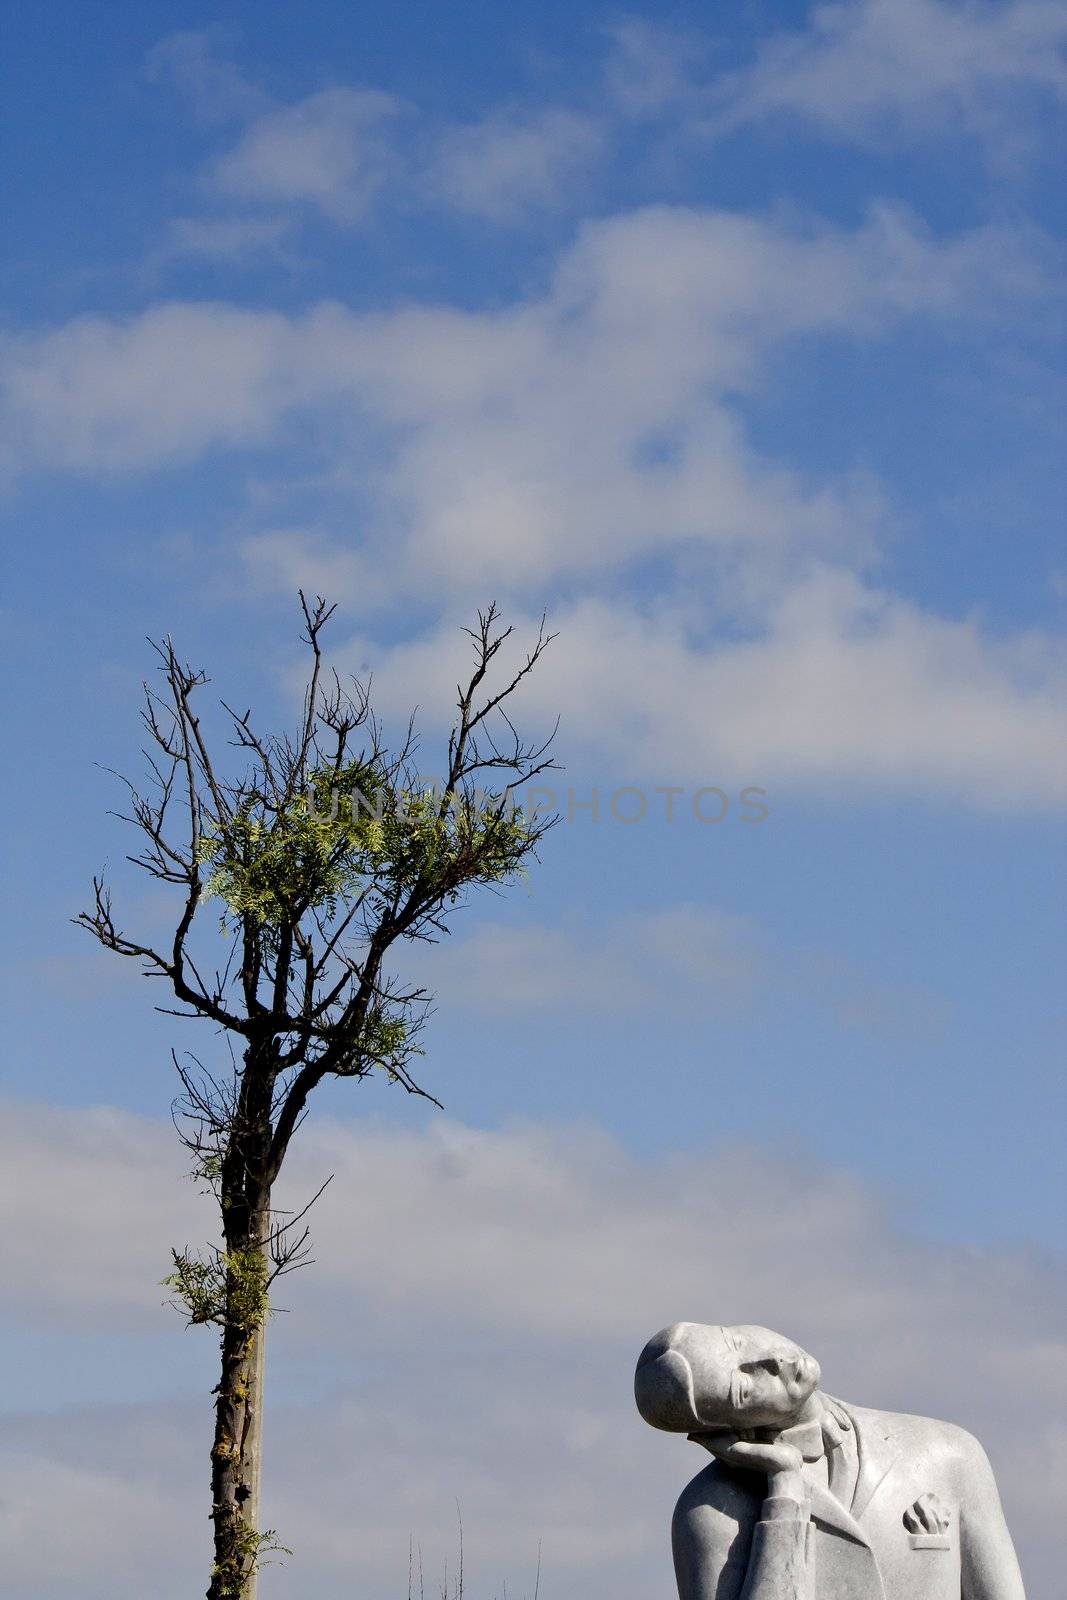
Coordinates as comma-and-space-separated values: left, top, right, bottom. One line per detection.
633, 1322, 1024, 1600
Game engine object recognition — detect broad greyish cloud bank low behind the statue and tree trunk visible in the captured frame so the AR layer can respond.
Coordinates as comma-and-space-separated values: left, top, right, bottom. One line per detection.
0, 1107, 1067, 1600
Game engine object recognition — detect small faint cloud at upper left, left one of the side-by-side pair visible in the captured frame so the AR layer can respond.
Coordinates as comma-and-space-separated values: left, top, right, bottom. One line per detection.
206, 88, 400, 222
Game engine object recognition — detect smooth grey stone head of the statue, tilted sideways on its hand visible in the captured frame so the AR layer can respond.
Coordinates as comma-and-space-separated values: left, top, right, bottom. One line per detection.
633, 1322, 822, 1434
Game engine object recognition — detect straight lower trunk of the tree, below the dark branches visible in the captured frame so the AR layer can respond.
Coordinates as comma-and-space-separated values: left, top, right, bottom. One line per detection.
208, 1203, 269, 1600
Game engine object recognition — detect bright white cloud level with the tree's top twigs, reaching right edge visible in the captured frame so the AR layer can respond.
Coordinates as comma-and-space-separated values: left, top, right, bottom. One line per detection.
334, 568, 1067, 811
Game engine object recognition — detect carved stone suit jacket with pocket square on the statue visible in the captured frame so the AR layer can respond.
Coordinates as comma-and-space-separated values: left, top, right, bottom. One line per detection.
672, 1402, 1025, 1600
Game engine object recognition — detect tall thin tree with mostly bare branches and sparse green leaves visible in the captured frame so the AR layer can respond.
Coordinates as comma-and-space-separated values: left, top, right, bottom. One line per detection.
75, 594, 553, 1600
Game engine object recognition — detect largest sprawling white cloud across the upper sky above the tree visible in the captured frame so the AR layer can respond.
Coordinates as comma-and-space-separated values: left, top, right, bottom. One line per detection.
5, 208, 1064, 808
